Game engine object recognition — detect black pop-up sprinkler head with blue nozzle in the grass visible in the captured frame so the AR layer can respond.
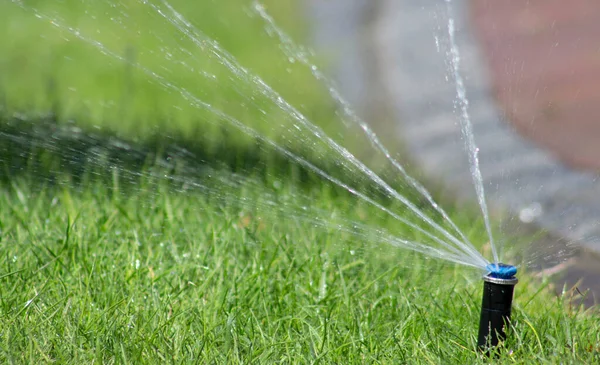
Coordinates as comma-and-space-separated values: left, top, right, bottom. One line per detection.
477, 264, 519, 350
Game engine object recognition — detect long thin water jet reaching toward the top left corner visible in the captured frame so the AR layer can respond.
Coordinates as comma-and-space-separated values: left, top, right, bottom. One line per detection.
13, 0, 488, 267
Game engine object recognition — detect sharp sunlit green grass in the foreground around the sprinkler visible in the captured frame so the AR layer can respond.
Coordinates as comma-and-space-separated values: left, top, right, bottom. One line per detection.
0, 176, 600, 364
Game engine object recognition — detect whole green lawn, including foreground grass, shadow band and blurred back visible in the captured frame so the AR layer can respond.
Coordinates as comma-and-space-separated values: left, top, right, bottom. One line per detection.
0, 1, 600, 364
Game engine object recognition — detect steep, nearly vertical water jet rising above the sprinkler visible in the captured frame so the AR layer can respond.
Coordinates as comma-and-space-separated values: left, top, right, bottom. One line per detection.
445, 0, 500, 262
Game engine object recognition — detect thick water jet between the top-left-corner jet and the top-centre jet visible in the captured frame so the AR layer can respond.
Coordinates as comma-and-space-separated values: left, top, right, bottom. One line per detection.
147, 0, 486, 268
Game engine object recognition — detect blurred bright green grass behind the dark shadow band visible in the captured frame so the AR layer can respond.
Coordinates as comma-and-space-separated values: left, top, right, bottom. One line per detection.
0, 0, 356, 147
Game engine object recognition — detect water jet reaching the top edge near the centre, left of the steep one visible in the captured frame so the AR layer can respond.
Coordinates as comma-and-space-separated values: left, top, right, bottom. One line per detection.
253, 0, 486, 262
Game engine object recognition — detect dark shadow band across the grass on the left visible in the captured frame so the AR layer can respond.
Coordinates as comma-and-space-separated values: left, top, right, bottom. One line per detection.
0, 115, 433, 218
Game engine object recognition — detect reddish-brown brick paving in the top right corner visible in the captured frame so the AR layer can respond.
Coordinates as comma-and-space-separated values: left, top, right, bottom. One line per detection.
470, 0, 600, 171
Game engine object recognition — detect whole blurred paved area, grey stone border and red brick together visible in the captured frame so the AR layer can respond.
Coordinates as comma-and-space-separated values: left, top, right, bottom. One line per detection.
311, 0, 600, 288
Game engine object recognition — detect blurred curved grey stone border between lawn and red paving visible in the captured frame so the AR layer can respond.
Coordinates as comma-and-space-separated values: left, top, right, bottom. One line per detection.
311, 0, 600, 292
